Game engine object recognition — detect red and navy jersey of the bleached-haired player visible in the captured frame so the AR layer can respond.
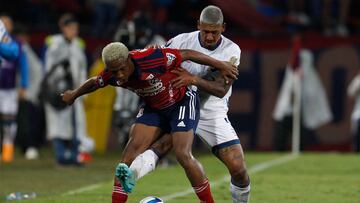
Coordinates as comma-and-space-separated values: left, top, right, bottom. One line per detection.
97, 48, 186, 109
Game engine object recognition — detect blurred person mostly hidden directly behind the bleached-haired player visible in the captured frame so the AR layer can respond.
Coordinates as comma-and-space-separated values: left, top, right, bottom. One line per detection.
113, 12, 166, 146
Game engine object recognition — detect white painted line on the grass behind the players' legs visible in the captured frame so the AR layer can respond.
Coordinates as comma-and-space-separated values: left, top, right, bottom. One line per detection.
160, 154, 298, 202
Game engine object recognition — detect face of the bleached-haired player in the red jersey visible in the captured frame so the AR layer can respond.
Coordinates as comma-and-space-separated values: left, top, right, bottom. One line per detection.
106, 60, 132, 85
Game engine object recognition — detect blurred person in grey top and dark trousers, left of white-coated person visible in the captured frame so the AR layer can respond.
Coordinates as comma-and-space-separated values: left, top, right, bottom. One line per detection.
15, 25, 45, 160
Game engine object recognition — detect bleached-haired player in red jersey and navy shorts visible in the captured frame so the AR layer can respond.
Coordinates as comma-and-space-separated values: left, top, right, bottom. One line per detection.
62, 42, 238, 203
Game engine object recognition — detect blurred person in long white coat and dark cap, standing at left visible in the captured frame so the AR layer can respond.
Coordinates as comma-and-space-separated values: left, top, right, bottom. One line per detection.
42, 14, 93, 165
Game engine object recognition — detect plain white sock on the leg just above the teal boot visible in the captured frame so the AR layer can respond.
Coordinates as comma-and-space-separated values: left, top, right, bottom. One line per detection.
130, 149, 159, 180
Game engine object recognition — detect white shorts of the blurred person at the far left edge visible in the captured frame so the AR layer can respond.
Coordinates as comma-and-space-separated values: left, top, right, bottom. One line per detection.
0, 89, 18, 115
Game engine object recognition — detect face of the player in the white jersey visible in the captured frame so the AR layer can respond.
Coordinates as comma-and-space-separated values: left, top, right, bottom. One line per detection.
198, 22, 225, 49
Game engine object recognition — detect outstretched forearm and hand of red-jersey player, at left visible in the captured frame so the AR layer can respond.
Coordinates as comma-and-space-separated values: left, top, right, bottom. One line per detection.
61, 77, 99, 105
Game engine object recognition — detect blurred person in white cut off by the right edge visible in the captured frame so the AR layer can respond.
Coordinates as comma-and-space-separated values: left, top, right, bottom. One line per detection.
347, 72, 360, 152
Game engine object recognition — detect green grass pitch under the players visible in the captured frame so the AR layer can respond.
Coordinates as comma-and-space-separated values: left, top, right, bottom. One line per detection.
0, 153, 360, 203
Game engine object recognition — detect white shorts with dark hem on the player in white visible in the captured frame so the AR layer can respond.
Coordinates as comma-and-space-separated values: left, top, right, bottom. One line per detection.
196, 116, 240, 153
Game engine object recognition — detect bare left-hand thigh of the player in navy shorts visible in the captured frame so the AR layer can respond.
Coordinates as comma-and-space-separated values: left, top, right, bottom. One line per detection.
122, 123, 162, 164
